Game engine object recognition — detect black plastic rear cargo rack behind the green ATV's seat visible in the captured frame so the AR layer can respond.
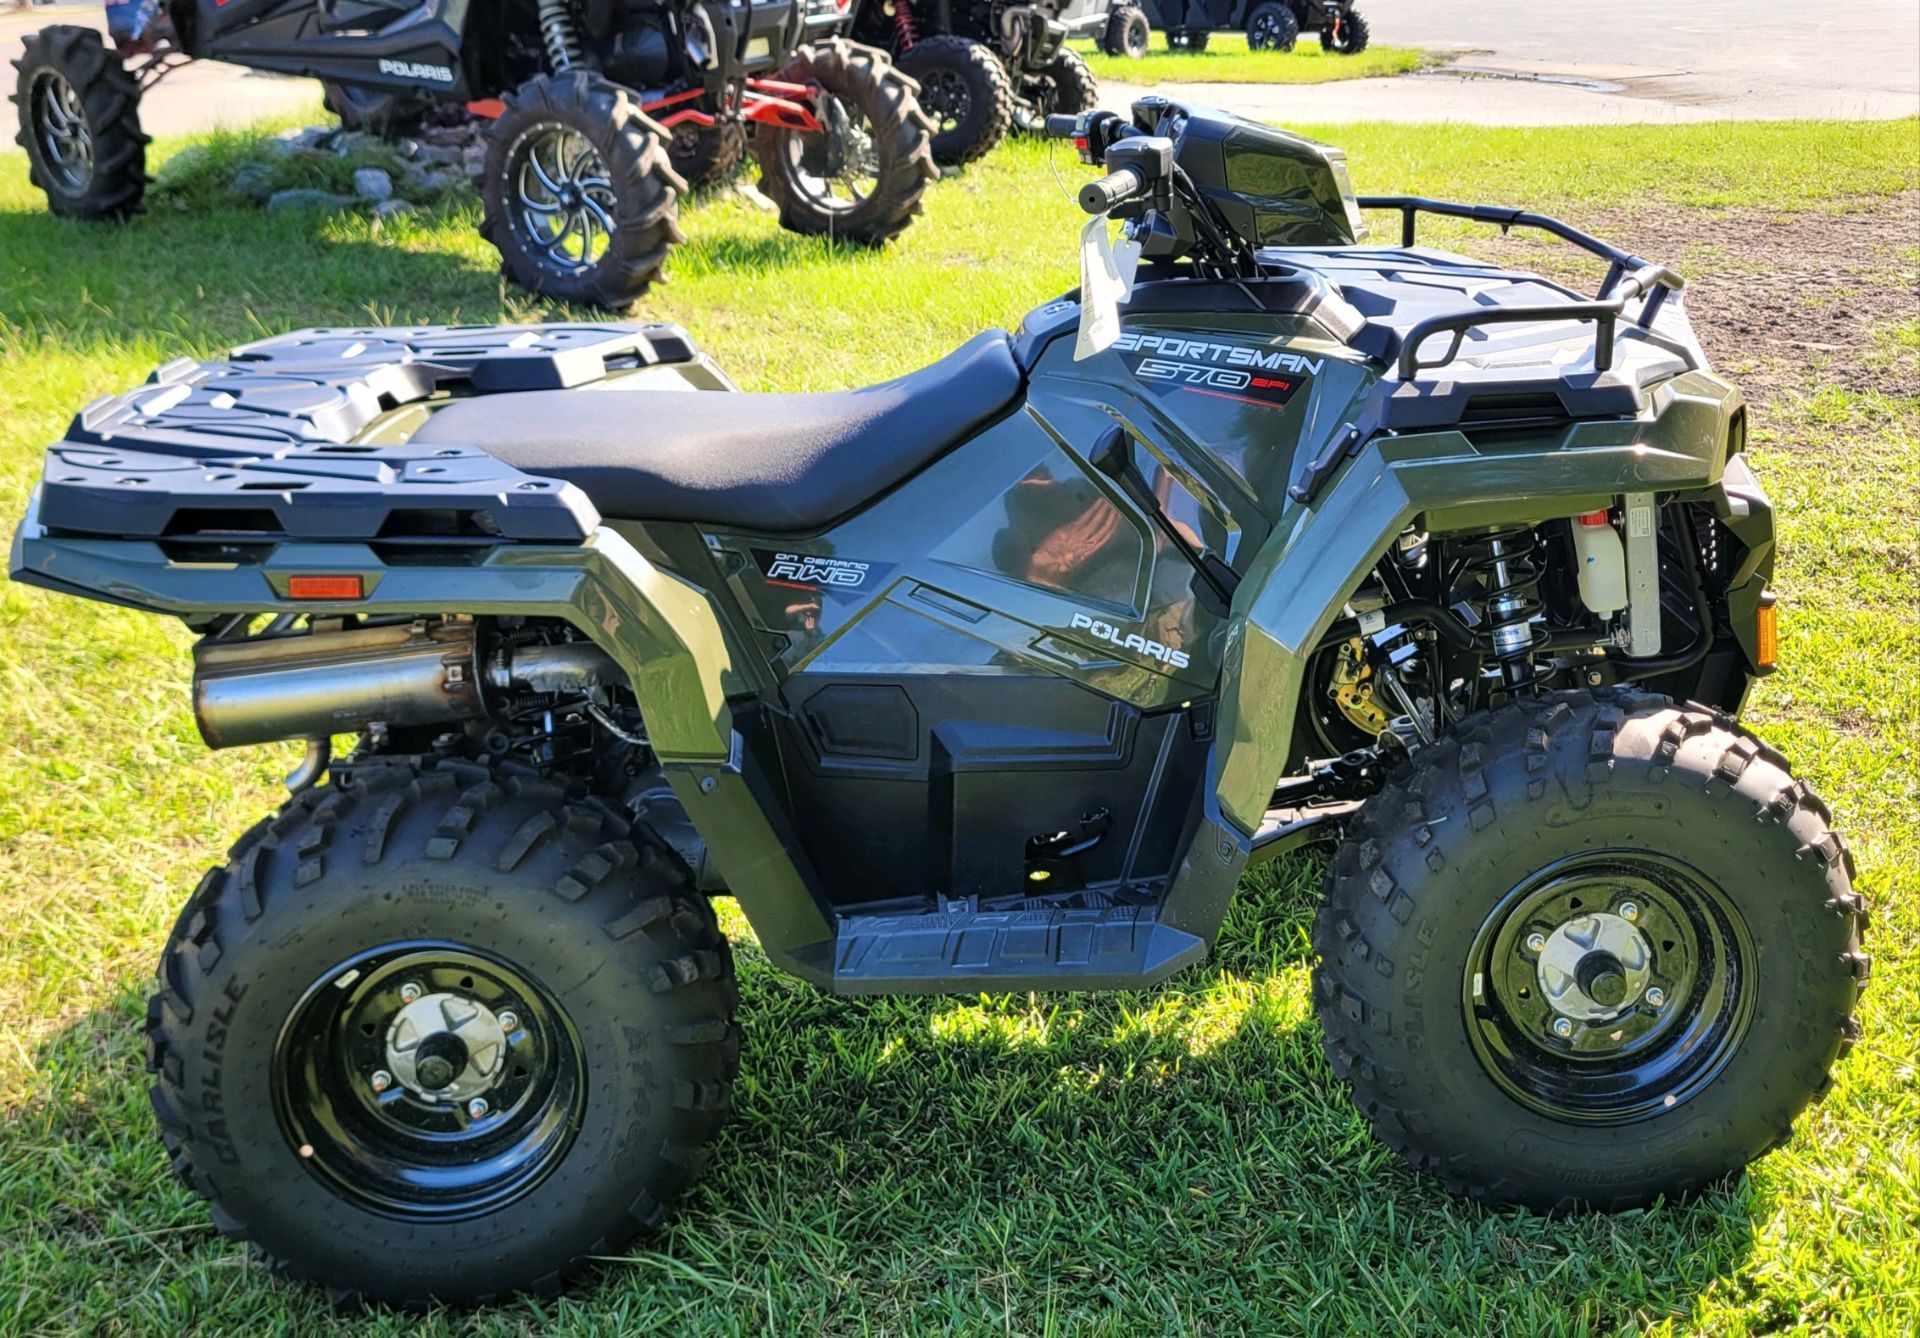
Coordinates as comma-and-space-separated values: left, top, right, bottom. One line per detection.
38, 324, 699, 545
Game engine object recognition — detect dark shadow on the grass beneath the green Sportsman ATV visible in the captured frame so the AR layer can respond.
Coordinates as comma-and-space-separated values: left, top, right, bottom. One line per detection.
0, 862, 1757, 1334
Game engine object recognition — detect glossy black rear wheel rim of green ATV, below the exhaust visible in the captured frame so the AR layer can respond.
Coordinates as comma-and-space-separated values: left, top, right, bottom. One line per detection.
273, 943, 588, 1219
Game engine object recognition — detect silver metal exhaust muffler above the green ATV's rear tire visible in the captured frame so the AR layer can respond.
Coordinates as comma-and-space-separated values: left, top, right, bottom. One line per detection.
194, 620, 626, 749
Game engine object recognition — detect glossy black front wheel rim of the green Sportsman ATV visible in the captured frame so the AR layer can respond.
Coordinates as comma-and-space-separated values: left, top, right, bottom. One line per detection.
1461, 850, 1755, 1125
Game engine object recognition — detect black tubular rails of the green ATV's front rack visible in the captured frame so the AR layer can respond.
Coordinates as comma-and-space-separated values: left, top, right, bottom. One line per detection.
1359, 196, 1693, 380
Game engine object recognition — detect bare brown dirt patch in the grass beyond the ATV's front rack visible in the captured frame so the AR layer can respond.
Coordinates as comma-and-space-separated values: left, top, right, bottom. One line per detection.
1465, 190, 1920, 405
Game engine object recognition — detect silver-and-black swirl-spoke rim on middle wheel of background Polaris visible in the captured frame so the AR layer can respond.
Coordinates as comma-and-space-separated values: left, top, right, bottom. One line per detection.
507, 123, 620, 276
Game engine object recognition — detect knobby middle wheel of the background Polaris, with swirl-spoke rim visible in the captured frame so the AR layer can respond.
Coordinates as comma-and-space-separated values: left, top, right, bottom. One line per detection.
480, 71, 687, 311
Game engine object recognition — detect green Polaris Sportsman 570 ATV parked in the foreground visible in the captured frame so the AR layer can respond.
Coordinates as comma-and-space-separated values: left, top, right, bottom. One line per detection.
12, 100, 1868, 1302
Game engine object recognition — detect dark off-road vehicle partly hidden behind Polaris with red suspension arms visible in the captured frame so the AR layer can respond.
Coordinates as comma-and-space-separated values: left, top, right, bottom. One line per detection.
849, 0, 1110, 167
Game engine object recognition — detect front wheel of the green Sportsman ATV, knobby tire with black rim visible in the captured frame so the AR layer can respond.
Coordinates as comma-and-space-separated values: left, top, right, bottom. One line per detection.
1313, 689, 1868, 1211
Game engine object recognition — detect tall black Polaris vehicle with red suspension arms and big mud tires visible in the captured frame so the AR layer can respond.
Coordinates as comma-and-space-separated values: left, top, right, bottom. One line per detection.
13, 0, 939, 307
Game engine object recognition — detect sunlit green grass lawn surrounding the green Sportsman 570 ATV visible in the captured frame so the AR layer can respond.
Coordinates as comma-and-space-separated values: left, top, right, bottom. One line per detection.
0, 119, 1920, 1336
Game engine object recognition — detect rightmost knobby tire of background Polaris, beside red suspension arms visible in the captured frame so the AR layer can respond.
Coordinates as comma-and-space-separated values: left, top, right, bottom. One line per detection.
753, 38, 941, 246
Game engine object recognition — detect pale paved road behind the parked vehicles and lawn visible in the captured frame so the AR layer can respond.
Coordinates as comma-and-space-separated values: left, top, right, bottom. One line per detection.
0, 0, 1920, 152
